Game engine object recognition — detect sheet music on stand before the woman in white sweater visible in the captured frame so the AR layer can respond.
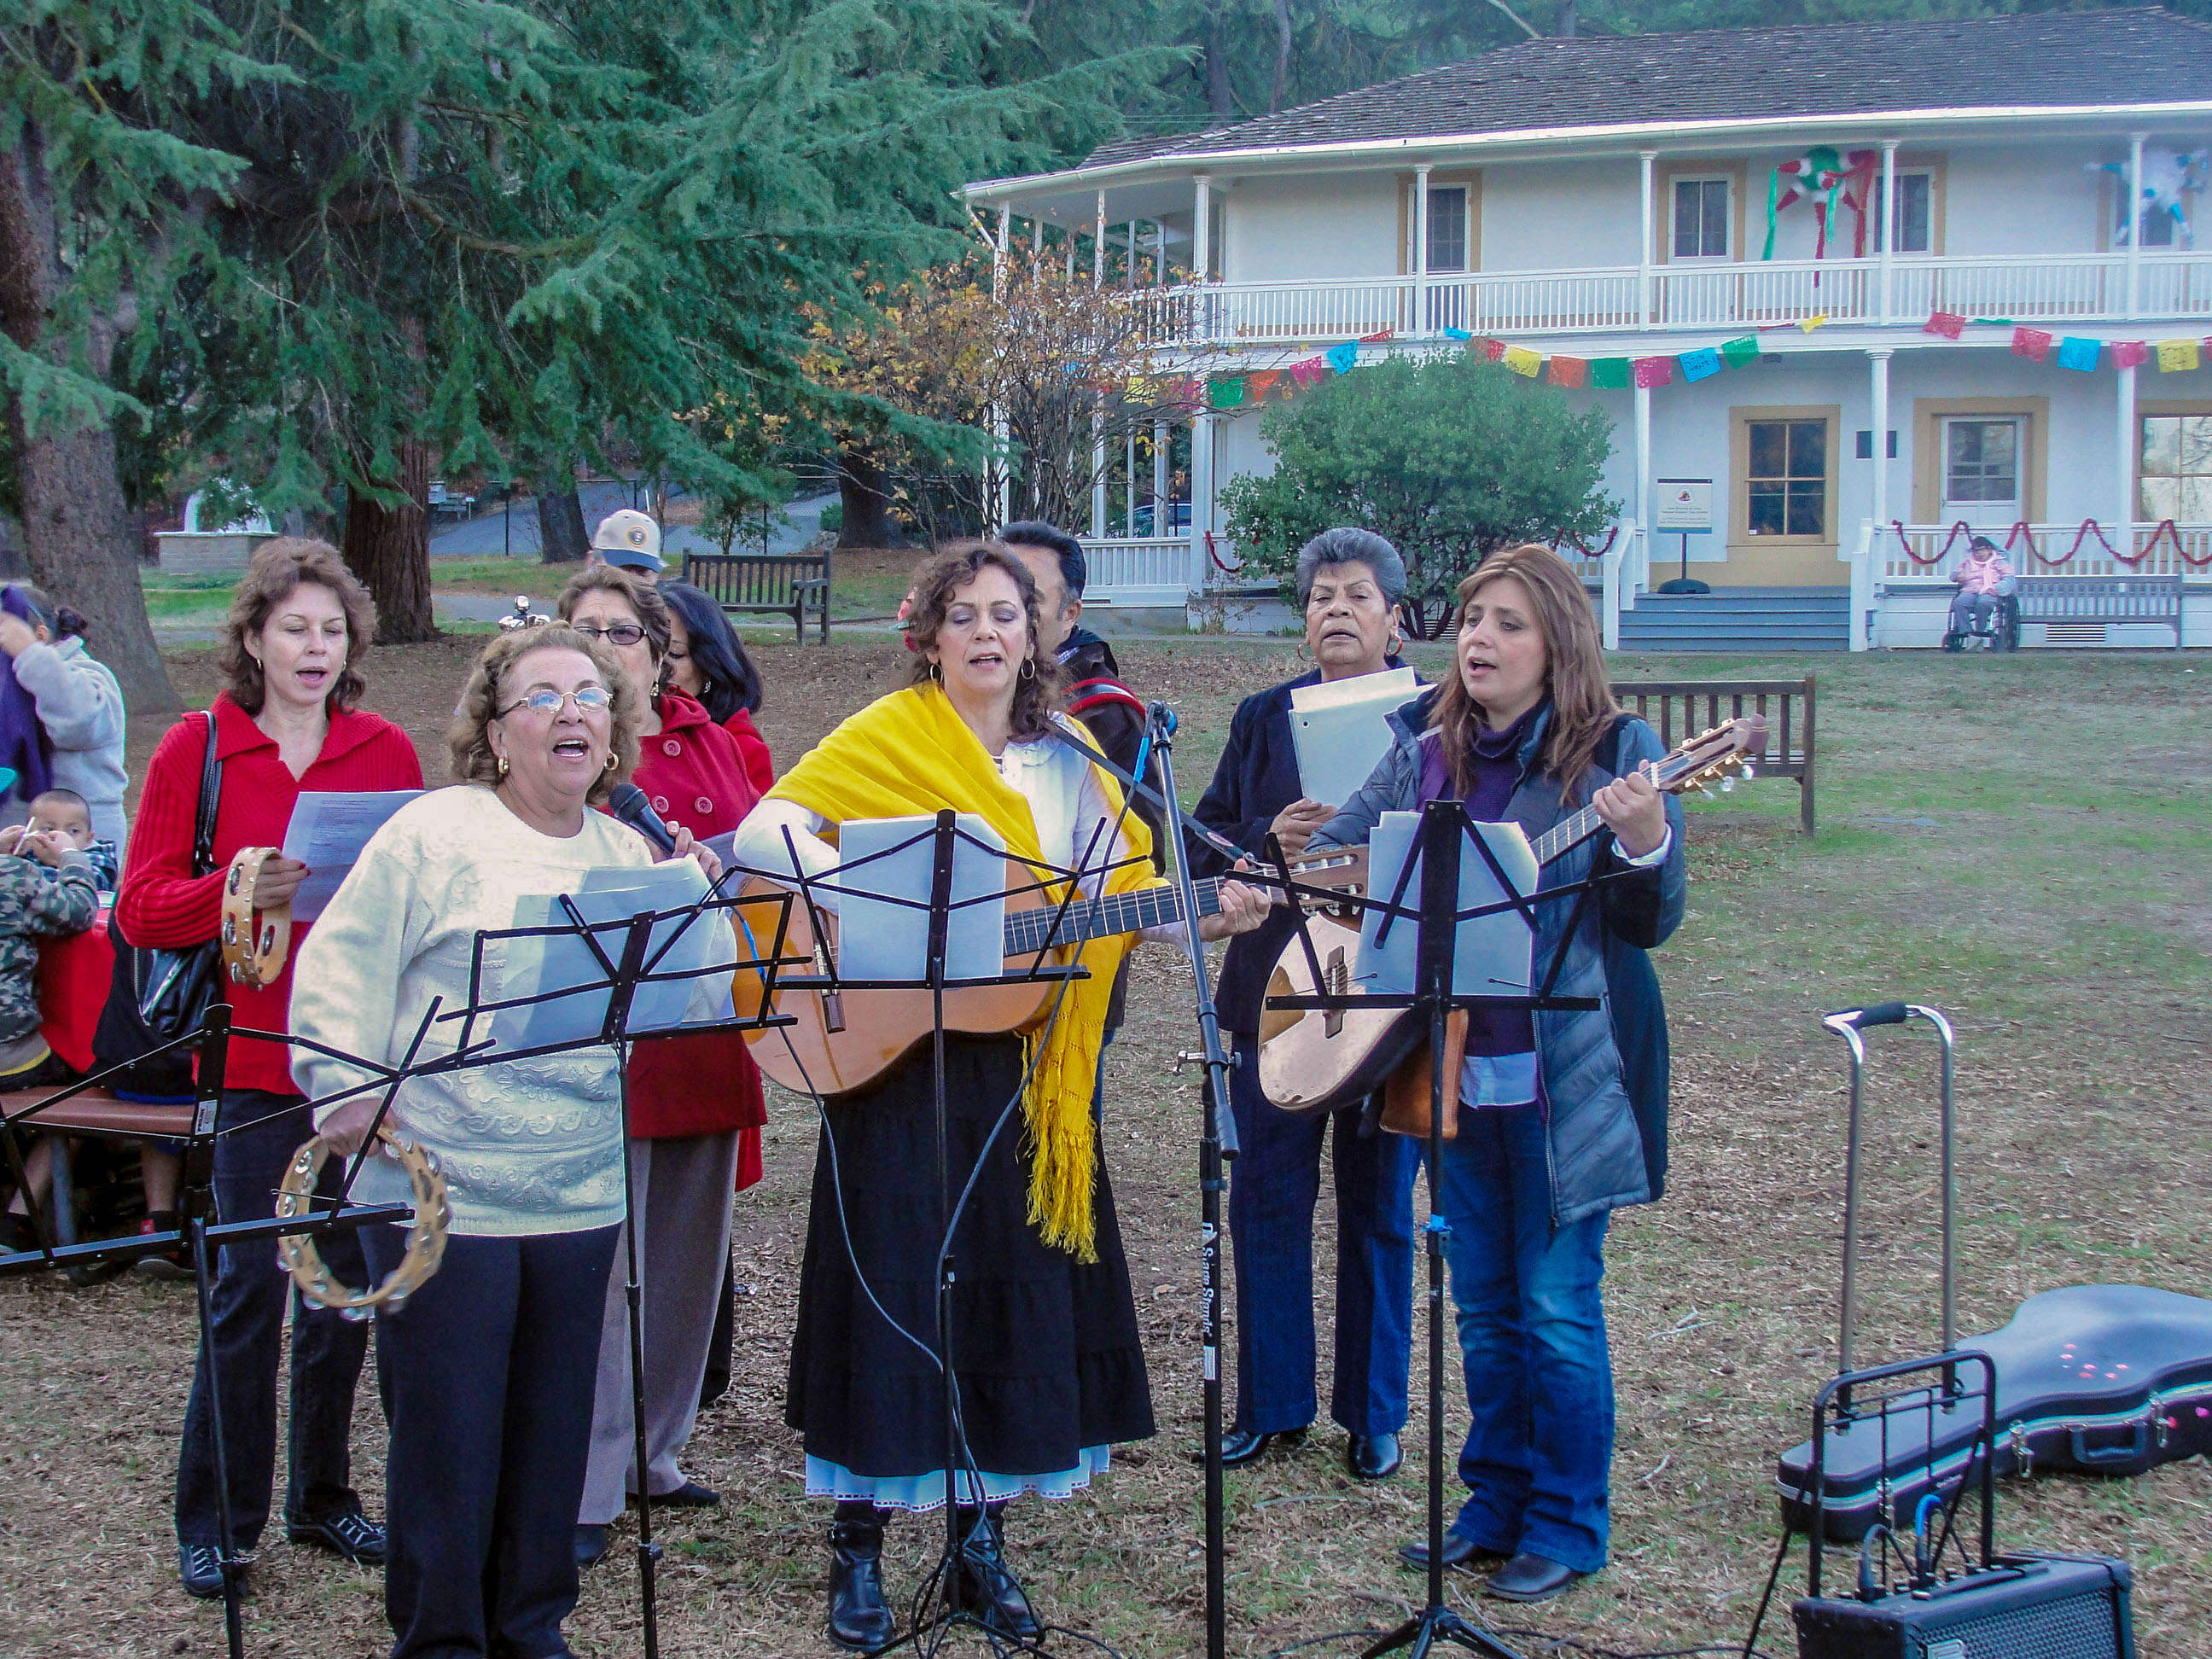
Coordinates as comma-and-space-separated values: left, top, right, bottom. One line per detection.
486, 859, 736, 1049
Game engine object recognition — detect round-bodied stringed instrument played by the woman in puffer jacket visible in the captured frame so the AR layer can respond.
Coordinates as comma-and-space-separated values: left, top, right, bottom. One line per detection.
1259, 714, 1767, 1113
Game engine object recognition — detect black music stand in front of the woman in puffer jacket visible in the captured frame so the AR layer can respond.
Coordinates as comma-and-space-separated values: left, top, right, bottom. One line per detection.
1267, 800, 1606, 1659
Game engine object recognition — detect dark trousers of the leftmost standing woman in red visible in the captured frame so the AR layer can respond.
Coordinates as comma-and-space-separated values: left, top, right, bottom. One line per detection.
177, 1088, 370, 1548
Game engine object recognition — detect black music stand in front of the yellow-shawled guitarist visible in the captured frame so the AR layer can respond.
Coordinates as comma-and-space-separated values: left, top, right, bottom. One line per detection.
742, 810, 1115, 1652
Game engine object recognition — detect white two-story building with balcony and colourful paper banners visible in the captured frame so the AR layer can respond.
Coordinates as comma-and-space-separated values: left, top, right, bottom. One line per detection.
967, 9, 2212, 648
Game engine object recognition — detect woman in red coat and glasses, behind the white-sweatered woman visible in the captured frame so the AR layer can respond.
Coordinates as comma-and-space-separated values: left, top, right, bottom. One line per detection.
560, 564, 767, 1566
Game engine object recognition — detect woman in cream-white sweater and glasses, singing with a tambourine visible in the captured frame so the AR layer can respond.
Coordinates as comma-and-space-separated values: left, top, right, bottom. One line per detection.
292, 626, 719, 1659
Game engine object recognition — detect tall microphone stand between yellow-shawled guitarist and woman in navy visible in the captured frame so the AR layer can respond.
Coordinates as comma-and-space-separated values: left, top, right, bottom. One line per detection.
1148, 703, 1239, 1659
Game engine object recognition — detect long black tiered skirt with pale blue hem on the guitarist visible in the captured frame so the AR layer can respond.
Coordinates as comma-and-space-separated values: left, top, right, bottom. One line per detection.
785, 1035, 1152, 1509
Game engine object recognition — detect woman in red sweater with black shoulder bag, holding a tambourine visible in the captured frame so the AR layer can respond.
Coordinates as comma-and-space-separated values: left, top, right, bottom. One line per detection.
113, 535, 422, 1597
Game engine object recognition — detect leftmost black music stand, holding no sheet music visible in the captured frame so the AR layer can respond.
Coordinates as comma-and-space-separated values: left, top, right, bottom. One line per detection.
0, 1002, 422, 1659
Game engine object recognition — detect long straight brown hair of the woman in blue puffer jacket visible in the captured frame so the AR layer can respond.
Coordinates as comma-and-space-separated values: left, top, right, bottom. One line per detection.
1429, 542, 1621, 805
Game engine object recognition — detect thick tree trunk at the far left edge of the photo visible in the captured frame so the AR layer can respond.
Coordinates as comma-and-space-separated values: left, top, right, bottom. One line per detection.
0, 117, 182, 710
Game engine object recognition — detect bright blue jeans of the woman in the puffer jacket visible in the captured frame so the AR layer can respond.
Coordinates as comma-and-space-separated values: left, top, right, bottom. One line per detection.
1434, 1106, 1613, 1573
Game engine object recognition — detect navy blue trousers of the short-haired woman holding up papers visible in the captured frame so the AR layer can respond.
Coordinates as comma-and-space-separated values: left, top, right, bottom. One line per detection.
1230, 1031, 1417, 1435
